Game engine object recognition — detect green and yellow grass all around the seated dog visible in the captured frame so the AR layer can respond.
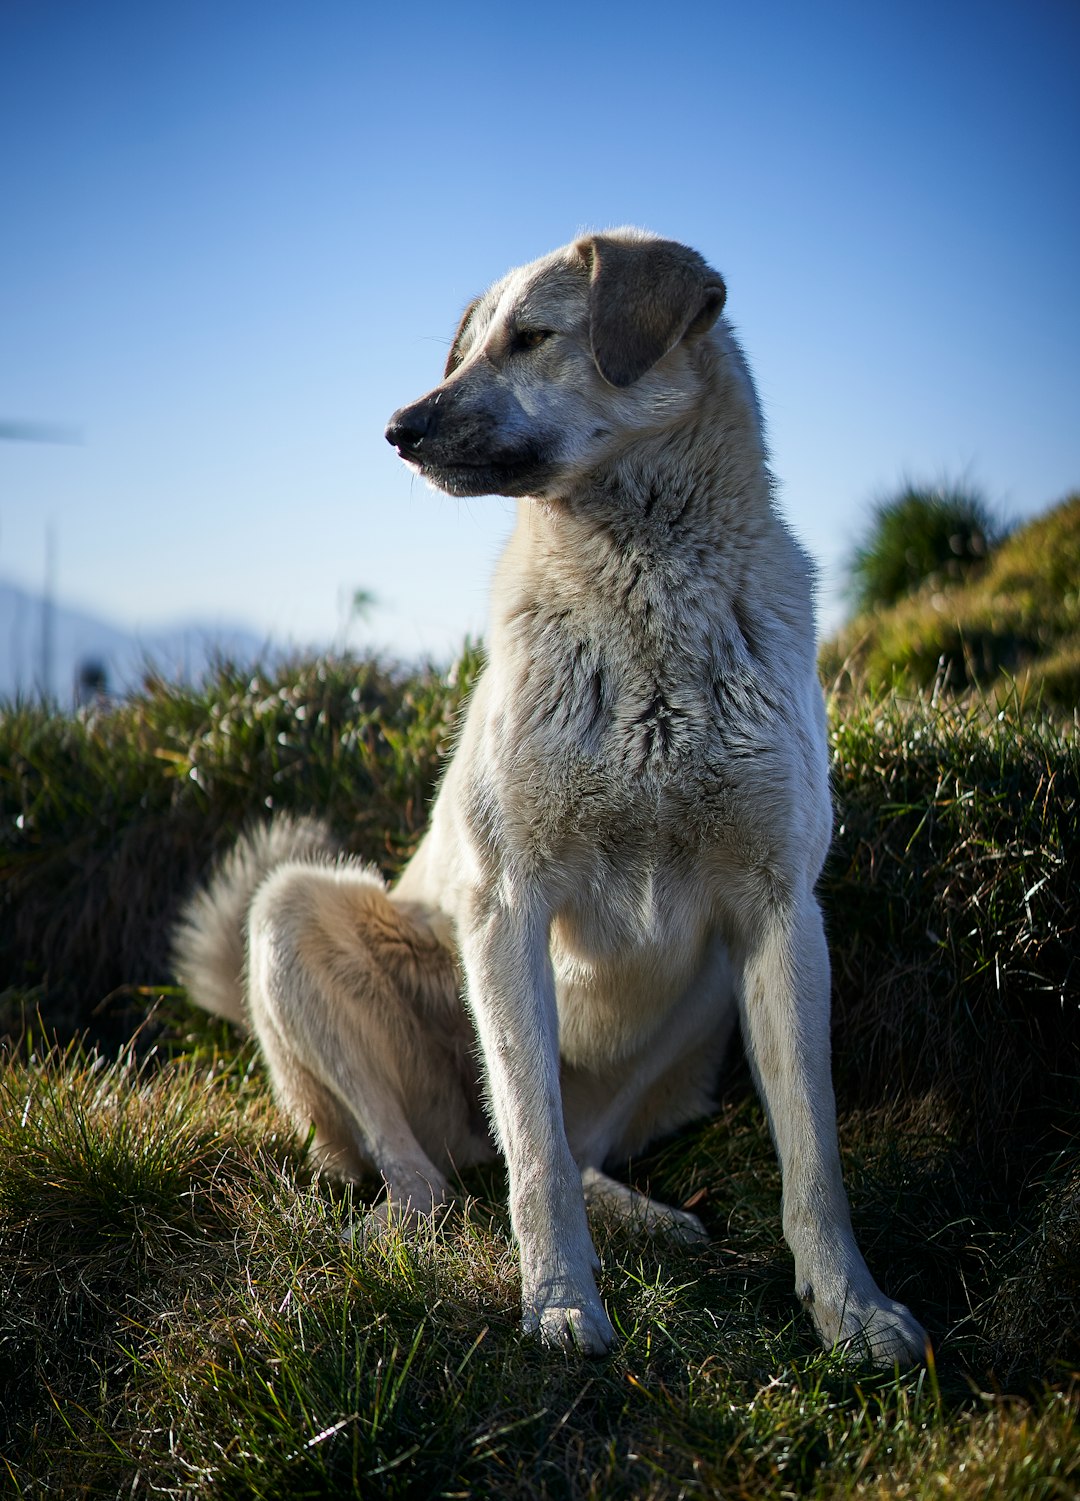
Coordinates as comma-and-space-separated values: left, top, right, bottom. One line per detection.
0, 651, 1080, 1498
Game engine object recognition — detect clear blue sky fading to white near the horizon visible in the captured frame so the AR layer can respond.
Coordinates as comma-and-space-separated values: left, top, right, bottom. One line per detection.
0, 0, 1080, 657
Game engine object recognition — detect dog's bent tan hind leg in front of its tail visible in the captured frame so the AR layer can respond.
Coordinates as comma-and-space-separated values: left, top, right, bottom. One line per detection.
248, 862, 491, 1217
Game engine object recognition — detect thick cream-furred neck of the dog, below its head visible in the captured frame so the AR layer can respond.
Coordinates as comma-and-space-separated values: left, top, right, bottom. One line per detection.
491, 330, 813, 675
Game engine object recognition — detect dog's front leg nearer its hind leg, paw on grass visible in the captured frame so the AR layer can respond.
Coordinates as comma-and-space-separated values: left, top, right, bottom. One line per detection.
462, 902, 615, 1355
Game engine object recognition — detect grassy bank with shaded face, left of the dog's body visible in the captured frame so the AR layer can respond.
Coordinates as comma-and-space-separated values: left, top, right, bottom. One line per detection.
0, 648, 479, 1046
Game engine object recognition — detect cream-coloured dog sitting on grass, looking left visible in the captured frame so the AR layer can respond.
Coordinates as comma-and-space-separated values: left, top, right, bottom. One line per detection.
174, 230, 926, 1366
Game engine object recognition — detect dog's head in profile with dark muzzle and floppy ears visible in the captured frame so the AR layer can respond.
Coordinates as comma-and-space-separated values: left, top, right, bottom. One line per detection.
386, 230, 725, 495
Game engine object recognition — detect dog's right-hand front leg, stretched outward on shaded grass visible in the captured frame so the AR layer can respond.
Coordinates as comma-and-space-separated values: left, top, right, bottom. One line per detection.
741, 887, 926, 1366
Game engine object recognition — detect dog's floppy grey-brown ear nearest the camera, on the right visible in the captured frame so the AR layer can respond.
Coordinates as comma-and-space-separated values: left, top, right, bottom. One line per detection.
575, 234, 728, 386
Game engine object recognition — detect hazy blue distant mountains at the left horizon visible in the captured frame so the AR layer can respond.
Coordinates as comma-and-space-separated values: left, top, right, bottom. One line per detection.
0, 581, 279, 704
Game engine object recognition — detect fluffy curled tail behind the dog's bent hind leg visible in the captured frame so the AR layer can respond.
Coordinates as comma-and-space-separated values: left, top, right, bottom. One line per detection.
173, 814, 338, 1028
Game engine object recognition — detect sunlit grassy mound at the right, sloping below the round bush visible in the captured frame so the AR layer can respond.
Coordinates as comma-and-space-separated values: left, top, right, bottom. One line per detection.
822, 494, 1080, 713
